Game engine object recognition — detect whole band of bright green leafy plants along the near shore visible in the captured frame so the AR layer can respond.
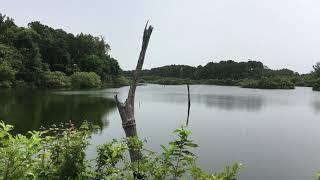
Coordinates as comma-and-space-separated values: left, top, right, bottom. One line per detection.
0, 122, 240, 180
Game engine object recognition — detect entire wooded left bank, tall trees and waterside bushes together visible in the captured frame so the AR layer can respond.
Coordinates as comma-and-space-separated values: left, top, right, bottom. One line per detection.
0, 14, 126, 88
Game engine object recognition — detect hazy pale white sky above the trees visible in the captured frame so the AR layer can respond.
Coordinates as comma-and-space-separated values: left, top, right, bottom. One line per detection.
0, 0, 320, 73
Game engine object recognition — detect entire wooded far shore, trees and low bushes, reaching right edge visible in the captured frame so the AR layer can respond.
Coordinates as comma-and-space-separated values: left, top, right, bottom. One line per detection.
125, 60, 320, 90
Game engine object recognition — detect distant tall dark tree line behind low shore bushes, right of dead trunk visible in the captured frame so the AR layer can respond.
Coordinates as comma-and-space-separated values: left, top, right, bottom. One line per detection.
125, 60, 299, 80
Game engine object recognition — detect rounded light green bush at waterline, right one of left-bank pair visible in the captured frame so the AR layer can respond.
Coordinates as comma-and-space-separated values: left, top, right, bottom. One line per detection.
71, 72, 101, 88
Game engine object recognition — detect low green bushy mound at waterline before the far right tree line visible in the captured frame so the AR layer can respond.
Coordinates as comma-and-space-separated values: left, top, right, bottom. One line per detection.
240, 77, 294, 89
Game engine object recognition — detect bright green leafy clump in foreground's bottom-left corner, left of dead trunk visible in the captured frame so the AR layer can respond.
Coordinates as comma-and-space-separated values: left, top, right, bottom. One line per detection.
0, 122, 95, 179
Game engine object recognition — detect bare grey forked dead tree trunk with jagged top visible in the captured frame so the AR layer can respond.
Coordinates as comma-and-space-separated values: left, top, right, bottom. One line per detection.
114, 22, 153, 162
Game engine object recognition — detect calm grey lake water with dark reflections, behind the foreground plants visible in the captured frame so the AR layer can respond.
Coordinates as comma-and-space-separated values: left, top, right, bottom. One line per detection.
0, 85, 320, 180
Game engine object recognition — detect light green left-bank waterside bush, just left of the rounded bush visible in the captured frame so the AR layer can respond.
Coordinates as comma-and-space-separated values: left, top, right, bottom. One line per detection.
40, 71, 71, 88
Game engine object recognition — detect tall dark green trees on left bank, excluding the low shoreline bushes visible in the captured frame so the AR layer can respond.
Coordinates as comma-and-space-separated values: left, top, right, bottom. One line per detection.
0, 14, 122, 86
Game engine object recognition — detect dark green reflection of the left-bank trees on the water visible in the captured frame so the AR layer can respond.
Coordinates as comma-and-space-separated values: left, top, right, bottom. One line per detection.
0, 90, 116, 133
